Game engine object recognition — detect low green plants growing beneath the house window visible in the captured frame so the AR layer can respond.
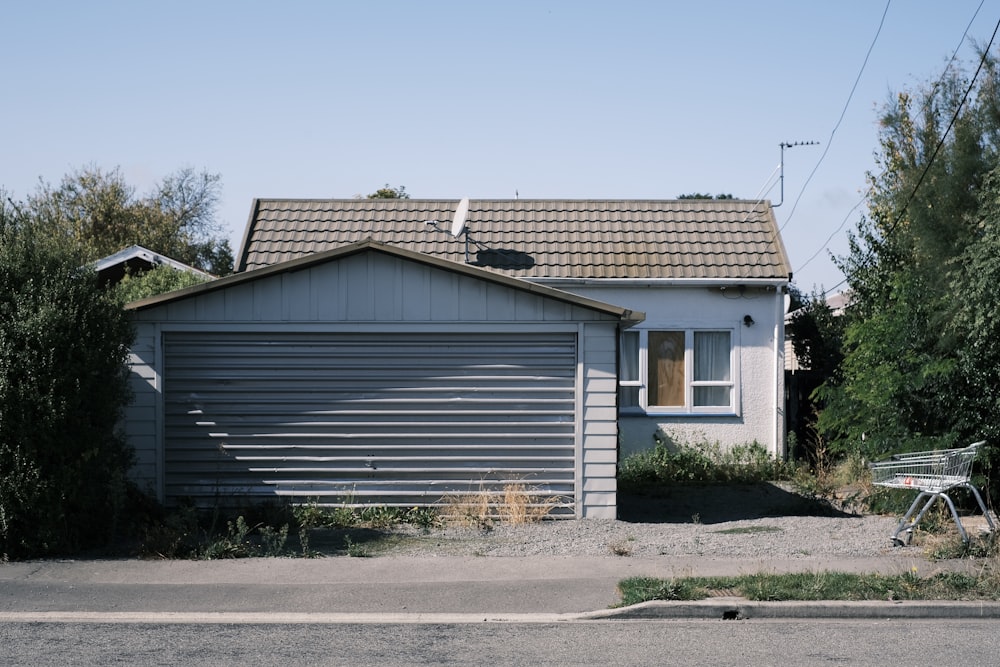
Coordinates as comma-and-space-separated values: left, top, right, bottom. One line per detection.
618, 438, 789, 490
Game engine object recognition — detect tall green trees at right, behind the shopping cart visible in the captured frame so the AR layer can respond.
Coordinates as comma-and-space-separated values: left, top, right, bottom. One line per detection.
817, 49, 1000, 458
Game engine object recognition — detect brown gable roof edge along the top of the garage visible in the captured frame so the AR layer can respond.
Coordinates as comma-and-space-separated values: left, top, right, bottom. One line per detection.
126, 240, 646, 323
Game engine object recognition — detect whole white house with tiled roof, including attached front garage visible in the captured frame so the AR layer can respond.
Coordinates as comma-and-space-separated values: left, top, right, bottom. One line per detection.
126, 199, 790, 518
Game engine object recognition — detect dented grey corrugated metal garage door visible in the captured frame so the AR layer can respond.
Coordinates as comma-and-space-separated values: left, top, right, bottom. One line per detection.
164, 333, 577, 512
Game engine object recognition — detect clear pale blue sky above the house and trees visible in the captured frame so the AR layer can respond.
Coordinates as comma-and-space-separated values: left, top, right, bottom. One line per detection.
0, 0, 1000, 292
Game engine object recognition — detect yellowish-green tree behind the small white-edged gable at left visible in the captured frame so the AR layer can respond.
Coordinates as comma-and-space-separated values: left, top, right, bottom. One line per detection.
24, 166, 233, 275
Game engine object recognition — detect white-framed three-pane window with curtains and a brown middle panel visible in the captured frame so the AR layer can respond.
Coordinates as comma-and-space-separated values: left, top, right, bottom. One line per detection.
618, 329, 737, 414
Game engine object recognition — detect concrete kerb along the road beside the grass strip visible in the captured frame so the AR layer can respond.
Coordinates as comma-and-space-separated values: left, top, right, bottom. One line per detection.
580, 598, 1000, 620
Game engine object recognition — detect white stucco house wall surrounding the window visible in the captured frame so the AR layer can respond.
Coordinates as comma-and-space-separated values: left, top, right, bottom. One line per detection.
544, 283, 785, 456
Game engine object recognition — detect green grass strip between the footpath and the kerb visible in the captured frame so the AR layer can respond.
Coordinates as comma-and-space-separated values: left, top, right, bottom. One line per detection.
618, 568, 1000, 606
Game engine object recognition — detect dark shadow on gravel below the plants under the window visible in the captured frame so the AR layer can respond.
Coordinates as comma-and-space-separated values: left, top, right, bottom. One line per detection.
618, 483, 858, 524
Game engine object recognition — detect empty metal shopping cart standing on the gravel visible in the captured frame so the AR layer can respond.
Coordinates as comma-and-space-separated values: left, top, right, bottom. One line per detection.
868, 440, 996, 546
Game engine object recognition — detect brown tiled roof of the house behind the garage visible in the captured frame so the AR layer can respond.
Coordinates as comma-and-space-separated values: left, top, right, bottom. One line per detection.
237, 199, 791, 281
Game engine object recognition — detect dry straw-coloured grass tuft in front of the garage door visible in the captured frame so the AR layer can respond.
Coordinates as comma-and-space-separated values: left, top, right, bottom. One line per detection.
441, 482, 564, 529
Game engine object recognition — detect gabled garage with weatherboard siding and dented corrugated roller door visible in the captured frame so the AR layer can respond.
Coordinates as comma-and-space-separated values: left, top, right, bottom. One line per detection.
124, 241, 642, 518
